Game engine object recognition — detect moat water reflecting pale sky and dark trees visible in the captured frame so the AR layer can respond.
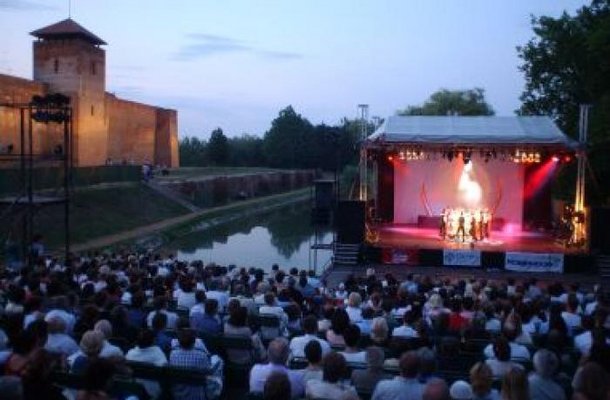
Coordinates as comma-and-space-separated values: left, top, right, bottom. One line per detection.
169, 202, 332, 269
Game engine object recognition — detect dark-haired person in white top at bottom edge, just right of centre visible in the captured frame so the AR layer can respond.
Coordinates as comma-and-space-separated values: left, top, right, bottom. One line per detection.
305, 352, 357, 399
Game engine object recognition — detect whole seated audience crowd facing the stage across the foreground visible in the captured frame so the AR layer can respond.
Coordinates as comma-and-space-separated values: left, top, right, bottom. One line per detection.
0, 253, 610, 400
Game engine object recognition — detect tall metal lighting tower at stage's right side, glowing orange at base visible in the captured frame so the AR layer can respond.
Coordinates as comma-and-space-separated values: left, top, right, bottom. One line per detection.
571, 104, 591, 246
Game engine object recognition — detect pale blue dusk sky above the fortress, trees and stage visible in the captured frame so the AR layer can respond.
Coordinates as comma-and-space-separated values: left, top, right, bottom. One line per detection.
0, 0, 588, 138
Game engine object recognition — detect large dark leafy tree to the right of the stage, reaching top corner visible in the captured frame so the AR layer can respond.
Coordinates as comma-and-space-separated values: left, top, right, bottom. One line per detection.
517, 0, 610, 203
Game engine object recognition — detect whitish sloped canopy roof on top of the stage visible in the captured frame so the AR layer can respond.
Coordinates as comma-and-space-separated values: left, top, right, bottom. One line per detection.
365, 116, 578, 149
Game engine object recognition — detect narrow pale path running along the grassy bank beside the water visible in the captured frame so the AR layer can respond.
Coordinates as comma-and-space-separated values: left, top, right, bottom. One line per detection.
71, 188, 310, 252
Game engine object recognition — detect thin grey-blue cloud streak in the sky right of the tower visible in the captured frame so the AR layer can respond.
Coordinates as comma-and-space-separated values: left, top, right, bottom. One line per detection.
172, 33, 302, 61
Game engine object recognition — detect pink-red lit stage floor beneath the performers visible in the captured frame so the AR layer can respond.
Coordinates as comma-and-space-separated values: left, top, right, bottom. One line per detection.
373, 224, 579, 254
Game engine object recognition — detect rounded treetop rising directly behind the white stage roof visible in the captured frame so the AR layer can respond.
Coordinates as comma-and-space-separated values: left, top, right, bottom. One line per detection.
398, 88, 494, 115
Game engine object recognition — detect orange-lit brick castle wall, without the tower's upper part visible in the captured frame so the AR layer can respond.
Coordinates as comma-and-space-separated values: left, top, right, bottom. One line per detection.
0, 74, 179, 167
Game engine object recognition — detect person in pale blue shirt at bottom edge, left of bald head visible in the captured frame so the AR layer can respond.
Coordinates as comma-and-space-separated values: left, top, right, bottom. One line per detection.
371, 351, 424, 400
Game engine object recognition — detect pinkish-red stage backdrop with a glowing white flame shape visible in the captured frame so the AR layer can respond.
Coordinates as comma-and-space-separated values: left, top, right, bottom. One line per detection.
393, 155, 524, 231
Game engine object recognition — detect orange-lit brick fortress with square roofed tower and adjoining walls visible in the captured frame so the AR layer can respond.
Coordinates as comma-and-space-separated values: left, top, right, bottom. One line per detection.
0, 19, 179, 167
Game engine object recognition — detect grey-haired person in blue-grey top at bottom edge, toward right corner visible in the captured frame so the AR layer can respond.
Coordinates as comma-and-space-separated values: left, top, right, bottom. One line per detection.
528, 349, 566, 400
